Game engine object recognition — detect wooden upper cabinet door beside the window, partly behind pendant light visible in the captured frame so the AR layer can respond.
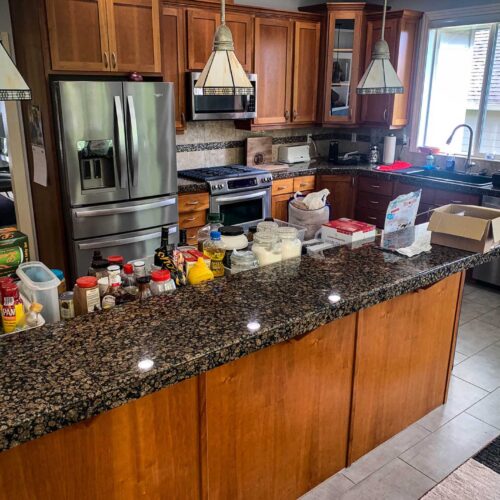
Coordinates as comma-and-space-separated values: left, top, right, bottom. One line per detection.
361, 19, 398, 126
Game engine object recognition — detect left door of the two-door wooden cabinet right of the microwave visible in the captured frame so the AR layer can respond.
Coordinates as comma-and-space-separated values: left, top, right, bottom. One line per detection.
255, 17, 293, 125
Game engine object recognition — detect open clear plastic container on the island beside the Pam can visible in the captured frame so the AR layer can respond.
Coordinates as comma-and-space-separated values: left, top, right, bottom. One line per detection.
16, 261, 61, 323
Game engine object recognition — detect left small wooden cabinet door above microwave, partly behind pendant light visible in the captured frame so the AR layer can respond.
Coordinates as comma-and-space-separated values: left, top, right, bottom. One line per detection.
186, 9, 220, 71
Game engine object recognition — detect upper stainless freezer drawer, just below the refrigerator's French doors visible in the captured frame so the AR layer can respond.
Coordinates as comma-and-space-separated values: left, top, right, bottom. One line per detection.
71, 195, 179, 240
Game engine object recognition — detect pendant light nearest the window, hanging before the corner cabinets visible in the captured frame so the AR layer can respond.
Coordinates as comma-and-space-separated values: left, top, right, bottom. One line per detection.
356, 0, 404, 95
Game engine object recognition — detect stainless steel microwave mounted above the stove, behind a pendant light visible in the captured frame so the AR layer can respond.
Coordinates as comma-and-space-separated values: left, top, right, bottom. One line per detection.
188, 72, 257, 121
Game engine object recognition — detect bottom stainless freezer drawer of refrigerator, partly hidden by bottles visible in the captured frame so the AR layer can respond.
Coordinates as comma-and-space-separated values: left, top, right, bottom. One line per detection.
73, 224, 179, 278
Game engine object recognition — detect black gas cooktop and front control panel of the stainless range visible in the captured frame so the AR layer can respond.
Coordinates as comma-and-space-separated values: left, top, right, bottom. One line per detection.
179, 165, 273, 195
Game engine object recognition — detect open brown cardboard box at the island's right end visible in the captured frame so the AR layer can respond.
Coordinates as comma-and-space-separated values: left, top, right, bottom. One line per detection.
429, 205, 500, 252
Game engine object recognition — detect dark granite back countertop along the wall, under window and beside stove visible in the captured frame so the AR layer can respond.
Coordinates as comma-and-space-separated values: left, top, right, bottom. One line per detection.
178, 160, 500, 197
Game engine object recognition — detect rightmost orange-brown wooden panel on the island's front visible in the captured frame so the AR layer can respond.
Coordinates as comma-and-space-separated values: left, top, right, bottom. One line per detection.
349, 274, 461, 463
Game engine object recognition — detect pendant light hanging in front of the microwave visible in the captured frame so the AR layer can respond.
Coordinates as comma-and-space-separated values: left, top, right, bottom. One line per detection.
194, 0, 254, 95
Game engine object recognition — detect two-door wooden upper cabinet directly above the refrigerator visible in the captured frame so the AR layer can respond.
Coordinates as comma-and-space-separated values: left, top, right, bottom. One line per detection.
45, 0, 161, 73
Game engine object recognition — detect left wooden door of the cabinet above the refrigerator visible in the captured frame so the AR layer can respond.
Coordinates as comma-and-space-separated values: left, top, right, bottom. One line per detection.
46, 0, 110, 71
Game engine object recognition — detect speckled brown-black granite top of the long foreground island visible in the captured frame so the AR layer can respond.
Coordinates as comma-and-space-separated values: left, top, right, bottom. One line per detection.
0, 229, 500, 451
